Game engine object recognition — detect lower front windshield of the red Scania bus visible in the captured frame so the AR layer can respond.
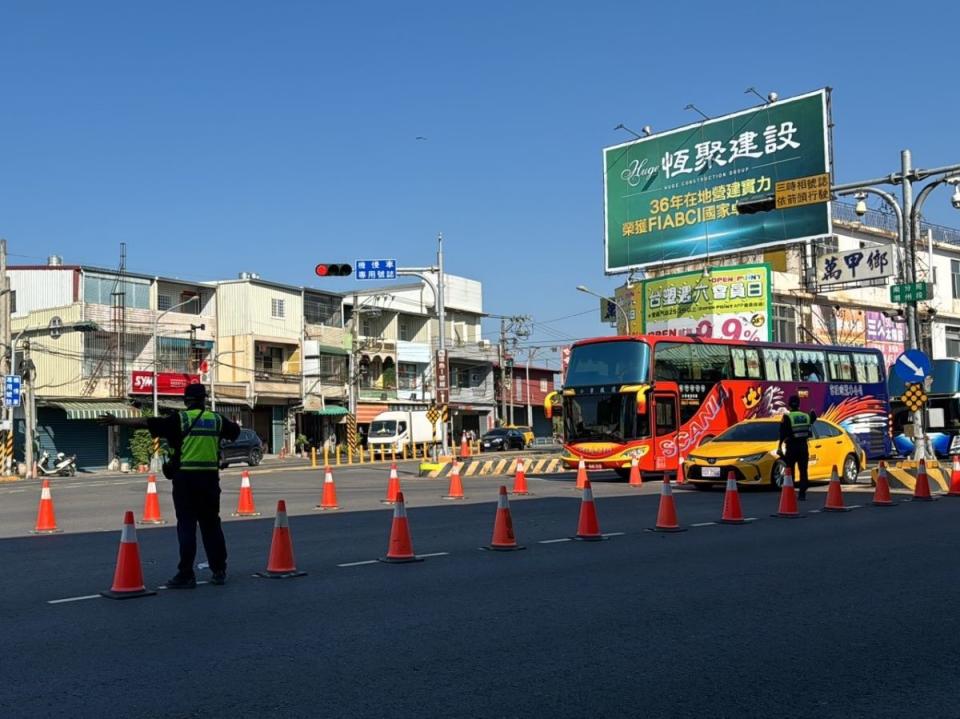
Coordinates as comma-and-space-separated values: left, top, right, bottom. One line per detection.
563, 393, 650, 442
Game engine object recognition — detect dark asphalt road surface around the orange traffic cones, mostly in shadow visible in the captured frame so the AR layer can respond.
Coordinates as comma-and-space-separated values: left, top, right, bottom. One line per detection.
0, 469, 960, 717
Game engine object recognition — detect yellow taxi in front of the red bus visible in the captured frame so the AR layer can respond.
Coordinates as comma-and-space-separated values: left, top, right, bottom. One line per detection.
683, 417, 867, 488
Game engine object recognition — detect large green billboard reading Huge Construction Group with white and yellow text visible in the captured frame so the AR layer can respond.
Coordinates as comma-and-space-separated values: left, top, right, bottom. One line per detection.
603, 90, 831, 272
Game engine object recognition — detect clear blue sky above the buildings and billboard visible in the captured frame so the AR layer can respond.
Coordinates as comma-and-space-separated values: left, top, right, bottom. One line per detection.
0, 0, 960, 366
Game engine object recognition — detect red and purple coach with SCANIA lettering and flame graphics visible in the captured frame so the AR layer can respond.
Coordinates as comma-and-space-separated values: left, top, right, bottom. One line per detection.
560, 335, 891, 475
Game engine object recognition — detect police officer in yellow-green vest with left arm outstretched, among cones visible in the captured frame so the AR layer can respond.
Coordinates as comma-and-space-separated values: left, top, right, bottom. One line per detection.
101, 384, 240, 589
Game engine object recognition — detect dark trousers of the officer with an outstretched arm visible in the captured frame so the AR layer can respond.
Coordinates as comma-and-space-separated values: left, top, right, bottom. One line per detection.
173, 476, 227, 574
